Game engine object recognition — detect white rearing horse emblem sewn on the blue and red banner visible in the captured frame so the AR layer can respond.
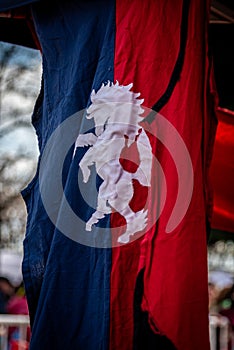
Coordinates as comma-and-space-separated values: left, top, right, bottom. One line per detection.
74, 82, 152, 243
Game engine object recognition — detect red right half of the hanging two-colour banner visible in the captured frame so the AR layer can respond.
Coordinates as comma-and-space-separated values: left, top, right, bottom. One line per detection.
110, 0, 215, 350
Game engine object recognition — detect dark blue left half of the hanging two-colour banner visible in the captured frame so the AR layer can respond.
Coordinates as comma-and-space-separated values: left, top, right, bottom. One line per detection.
22, 0, 115, 350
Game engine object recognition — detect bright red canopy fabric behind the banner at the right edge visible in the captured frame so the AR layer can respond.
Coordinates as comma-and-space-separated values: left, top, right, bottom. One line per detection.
211, 108, 234, 232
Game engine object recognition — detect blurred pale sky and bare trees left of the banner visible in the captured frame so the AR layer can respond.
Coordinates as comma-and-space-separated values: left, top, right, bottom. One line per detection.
0, 42, 41, 252
